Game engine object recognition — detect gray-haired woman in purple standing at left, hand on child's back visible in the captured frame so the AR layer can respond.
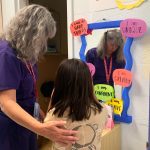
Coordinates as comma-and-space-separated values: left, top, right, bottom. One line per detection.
0, 5, 77, 150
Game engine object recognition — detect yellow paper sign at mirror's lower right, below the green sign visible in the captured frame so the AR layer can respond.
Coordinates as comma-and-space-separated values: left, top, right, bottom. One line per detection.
106, 98, 123, 116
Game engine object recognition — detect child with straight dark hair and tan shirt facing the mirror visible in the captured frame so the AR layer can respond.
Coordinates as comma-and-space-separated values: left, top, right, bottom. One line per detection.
45, 59, 108, 150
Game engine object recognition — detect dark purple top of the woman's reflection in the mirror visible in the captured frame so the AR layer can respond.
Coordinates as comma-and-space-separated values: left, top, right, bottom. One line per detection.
86, 48, 125, 86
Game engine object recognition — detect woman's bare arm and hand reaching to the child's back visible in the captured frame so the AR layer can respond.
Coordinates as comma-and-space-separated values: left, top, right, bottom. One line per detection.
0, 90, 77, 143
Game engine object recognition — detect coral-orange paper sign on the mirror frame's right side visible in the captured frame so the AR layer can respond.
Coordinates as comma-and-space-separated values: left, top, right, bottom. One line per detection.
113, 69, 132, 87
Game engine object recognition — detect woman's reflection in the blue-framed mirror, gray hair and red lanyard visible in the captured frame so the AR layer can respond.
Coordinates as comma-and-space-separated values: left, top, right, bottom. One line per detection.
86, 29, 125, 86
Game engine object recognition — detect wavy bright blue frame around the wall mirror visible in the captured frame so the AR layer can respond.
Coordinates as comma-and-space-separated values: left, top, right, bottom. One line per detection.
79, 20, 133, 123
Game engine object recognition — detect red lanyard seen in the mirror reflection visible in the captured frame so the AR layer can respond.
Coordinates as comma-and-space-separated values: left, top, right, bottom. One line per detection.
104, 57, 112, 84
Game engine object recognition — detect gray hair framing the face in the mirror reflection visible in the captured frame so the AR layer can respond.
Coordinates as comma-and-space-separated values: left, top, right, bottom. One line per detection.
97, 29, 125, 62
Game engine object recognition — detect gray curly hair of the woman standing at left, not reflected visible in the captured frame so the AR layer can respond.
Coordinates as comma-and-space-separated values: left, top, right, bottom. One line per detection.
1, 4, 56, 63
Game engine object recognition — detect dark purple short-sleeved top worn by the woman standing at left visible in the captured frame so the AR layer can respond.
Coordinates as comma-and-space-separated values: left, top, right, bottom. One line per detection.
0, 40, 37, 150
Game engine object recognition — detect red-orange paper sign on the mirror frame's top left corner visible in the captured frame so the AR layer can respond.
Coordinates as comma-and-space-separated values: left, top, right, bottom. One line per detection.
70, 19, 88, 36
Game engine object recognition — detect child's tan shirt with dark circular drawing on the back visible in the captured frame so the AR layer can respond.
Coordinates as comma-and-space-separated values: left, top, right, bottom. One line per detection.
45, 103, 108, 150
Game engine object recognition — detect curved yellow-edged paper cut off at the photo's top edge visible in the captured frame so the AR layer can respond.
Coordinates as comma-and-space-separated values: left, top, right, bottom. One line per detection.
116, 0, 145, 9
